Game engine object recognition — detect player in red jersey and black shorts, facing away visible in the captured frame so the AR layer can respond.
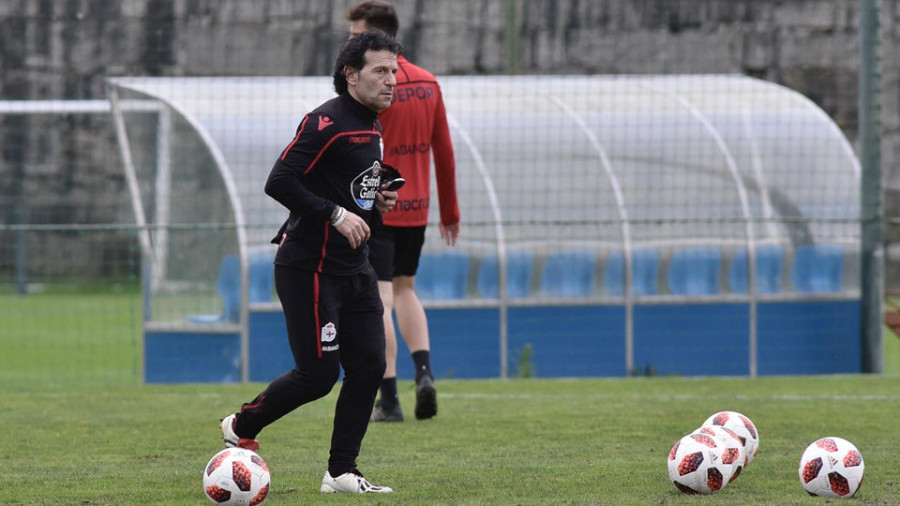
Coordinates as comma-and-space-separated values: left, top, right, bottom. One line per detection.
347, 0, 460, 421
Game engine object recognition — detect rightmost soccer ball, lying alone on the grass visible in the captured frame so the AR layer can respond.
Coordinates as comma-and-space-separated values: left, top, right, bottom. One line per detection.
798, 436, 866, 497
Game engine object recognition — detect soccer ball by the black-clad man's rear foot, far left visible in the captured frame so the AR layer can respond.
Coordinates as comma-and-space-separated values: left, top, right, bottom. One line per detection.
203, 448, 269, 506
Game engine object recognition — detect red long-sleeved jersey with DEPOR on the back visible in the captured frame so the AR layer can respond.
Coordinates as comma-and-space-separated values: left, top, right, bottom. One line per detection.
378, 56, 459, 227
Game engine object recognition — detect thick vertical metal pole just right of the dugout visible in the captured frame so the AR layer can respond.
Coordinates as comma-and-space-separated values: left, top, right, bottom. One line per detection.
859, 0, 884, 373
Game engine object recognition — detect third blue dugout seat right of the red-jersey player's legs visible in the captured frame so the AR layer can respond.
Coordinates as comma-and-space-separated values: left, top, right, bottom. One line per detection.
541, 250, 597, 297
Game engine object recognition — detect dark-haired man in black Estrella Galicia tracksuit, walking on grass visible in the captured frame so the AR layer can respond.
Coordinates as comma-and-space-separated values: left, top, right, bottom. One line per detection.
222, 32, 400, 492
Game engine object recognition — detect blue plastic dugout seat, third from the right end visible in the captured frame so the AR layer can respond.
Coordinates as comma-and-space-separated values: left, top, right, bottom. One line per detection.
667, 246, 722, 295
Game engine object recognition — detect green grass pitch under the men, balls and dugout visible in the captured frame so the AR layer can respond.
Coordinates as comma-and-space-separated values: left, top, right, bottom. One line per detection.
0, 294, 900, 505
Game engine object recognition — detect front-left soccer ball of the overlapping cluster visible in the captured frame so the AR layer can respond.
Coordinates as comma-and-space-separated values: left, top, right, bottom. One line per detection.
667, 434, 732, 494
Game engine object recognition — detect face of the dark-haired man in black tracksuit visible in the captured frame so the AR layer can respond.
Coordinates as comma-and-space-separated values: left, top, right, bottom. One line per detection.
344, 49, 398, 112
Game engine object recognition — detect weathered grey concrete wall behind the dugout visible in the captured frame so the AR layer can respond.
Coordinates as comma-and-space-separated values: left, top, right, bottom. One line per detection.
0, 0, 900, 284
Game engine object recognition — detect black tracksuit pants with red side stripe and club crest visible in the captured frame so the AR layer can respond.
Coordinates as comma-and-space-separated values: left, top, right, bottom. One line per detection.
235, 265, 385, 476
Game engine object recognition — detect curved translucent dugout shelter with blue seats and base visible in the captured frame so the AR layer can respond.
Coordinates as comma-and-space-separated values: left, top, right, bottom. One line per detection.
109, 75, 861, 382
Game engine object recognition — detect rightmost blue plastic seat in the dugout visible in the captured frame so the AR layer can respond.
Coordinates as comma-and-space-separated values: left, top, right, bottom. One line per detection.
791, 244, 844, 293
